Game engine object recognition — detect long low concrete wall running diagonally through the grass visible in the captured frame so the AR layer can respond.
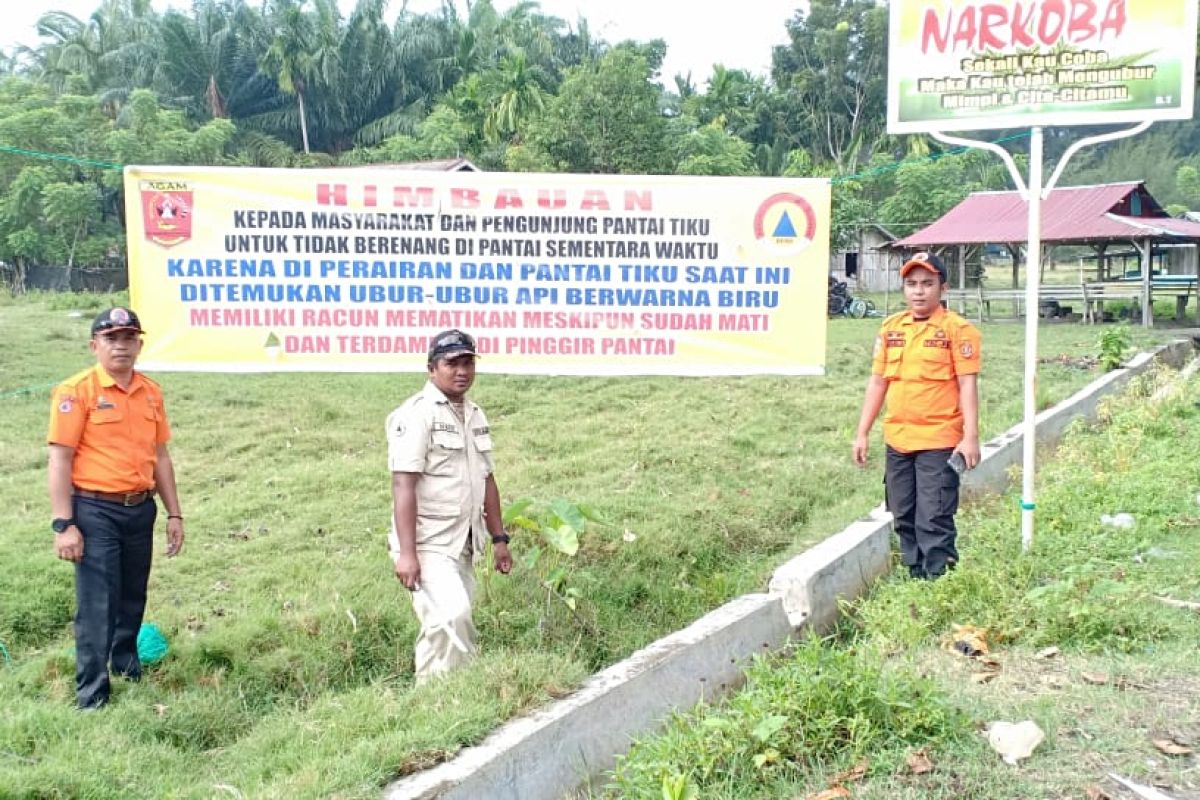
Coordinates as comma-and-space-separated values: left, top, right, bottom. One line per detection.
385, 341, 1194, 800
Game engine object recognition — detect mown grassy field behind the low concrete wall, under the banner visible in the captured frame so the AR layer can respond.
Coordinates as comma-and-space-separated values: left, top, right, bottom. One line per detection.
0, 296, 1165, 798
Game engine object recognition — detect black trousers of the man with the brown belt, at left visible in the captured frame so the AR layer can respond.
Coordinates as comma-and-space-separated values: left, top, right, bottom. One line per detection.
74, 495, 158, 708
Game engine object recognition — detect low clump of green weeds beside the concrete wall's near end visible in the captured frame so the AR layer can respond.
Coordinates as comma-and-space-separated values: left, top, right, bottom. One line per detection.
610, 637, 970, 800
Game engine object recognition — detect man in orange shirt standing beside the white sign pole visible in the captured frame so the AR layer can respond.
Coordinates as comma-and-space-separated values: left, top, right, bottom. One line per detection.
853, 253, 982, 578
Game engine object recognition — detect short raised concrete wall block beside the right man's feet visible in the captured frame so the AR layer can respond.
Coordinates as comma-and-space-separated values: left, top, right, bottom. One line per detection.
769, 505, 892, 631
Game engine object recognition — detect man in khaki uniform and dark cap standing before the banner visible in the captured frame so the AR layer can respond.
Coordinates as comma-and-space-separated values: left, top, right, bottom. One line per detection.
386, 330, 512, 682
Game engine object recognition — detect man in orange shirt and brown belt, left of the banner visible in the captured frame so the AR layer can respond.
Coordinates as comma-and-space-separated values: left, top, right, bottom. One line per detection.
48, 308, 184, 709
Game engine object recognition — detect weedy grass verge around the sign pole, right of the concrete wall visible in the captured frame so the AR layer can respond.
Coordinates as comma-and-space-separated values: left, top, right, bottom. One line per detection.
607, 367, 1200, 800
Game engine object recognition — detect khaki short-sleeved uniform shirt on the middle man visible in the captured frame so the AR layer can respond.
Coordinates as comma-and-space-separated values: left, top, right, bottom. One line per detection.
388, 383, 493, 559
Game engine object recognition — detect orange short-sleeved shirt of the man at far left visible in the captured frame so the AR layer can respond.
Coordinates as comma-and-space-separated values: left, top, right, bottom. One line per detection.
47, 363, 170, 492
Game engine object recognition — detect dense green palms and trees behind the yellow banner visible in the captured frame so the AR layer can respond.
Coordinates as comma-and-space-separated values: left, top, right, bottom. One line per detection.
0, 0, 1200, 292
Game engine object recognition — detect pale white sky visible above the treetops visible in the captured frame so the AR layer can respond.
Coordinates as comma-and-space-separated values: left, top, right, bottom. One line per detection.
0, 0, 806, 89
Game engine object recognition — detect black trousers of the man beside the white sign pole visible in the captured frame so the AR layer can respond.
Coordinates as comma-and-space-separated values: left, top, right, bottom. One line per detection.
883, 447, 959, 578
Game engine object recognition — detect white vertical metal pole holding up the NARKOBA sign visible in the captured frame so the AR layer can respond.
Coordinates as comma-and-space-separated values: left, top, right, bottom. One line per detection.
1021, 127, 1044, 552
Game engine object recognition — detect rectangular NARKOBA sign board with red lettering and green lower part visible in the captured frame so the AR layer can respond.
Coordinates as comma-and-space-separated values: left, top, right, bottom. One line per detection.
888, 0, 1198, 133
